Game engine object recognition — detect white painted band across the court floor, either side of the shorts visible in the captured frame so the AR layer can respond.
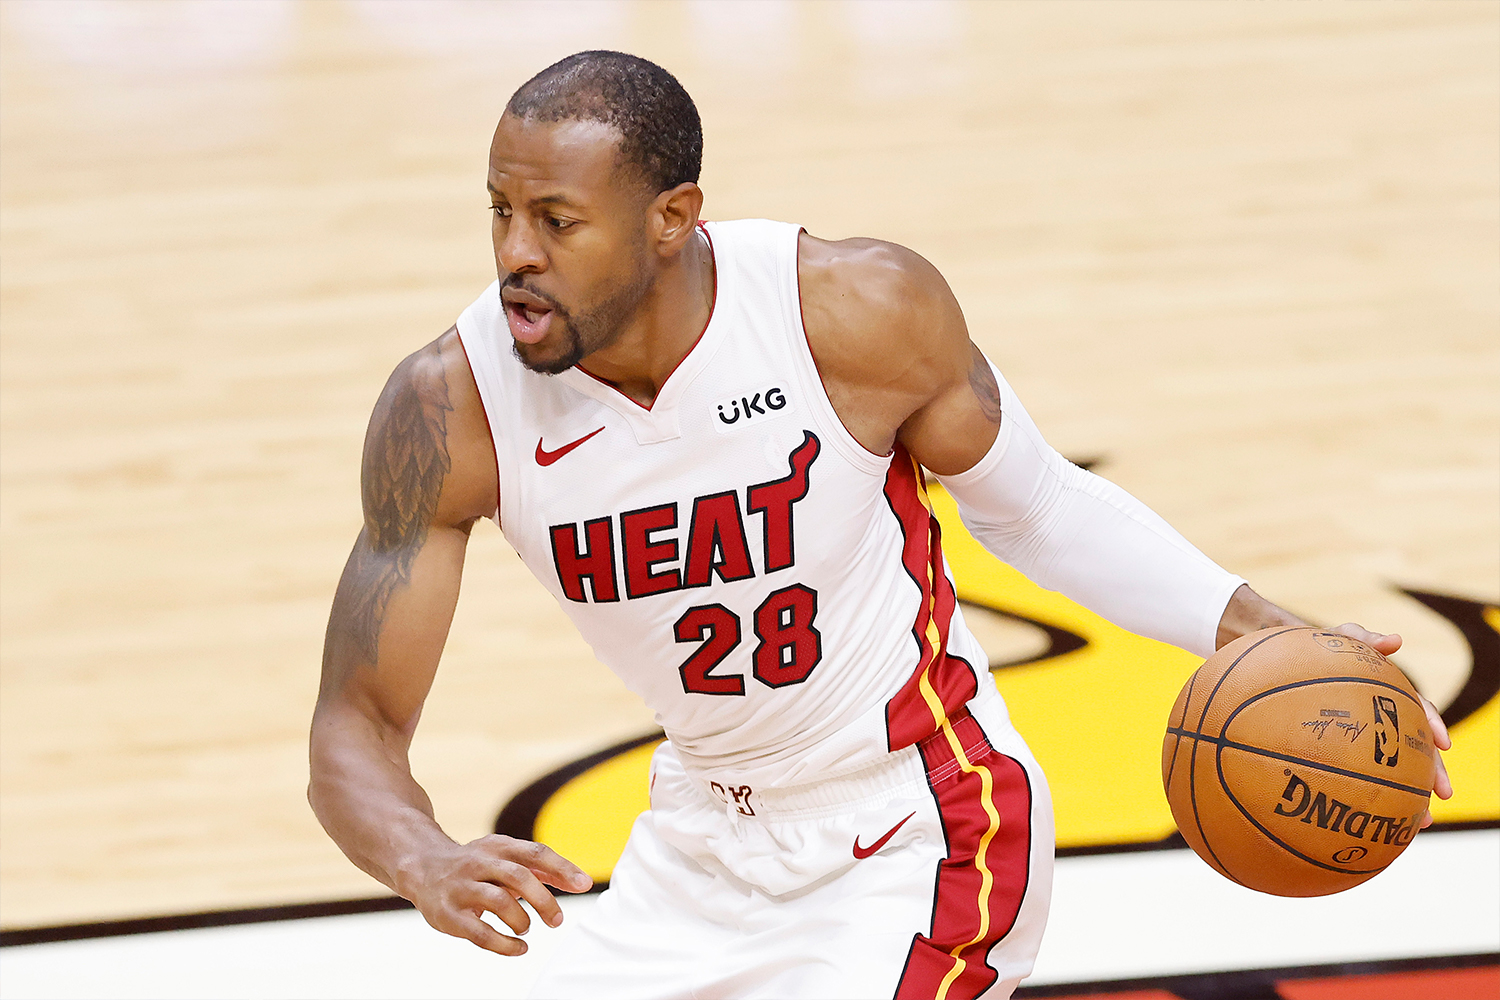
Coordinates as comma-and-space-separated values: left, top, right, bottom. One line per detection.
0, 829, 1500, 1000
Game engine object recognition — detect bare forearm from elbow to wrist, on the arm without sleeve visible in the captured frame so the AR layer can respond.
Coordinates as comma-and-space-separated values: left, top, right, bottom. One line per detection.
308, 709, 453, 892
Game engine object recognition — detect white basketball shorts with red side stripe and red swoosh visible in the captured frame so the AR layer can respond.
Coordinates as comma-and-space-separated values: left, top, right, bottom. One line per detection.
531, 697, 1053, 1000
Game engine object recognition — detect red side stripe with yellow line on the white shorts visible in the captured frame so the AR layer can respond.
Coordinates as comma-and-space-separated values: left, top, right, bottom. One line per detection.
896, 715, 1031, 1000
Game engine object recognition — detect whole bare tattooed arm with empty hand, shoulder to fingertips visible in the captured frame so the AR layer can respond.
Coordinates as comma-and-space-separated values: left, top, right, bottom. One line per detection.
308, 330, 591, 955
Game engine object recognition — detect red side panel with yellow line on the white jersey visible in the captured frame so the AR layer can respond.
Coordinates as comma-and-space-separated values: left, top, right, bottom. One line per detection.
885, 444, 978, 750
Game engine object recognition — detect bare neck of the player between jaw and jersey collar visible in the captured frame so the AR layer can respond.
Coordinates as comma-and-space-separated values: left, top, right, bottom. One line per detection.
582, 232, 716, 406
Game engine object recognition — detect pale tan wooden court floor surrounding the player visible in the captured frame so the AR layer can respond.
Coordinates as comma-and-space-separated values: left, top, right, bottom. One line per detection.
0, 0, 1500, 959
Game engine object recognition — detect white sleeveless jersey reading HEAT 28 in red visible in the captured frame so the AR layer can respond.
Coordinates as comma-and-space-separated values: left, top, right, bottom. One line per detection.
458, 220, 995, 787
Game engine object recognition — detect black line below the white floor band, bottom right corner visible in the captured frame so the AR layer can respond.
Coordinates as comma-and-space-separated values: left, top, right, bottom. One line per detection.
1014, 952, 1500, 1000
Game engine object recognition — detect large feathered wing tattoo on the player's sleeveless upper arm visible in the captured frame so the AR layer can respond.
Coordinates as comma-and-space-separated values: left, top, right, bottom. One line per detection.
333, 346, 453, 663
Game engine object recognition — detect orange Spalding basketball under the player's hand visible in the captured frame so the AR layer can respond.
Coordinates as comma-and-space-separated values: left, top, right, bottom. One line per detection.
1161, 627, 1437, 897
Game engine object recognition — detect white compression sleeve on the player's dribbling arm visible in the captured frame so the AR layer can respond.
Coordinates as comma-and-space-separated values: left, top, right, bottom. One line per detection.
938, 364, 1244, 657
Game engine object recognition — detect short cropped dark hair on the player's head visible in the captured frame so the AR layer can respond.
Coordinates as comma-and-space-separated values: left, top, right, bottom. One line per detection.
506, 49, 704, 193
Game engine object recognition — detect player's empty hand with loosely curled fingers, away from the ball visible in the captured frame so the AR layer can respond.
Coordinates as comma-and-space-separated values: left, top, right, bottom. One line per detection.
396, 834, 594, 955
